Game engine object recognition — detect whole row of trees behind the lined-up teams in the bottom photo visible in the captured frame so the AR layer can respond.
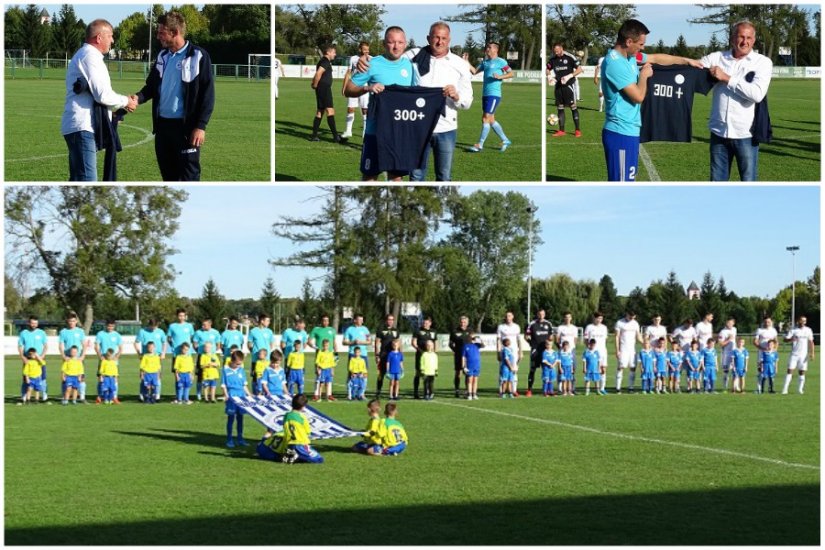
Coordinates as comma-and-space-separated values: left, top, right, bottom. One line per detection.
4, 189, 820, 332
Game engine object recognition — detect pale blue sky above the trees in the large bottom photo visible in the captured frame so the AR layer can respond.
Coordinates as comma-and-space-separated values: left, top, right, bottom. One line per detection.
166, 185, 820, 304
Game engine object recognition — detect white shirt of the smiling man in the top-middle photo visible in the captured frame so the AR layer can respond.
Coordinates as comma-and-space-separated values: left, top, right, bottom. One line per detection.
404, 48, 473, 134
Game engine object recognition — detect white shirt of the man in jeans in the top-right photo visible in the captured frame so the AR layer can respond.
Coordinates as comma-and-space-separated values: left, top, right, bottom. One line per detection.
702, 50, 773, 139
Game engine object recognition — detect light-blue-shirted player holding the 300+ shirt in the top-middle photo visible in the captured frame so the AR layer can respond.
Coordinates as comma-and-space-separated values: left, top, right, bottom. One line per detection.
344, 27, 415, 181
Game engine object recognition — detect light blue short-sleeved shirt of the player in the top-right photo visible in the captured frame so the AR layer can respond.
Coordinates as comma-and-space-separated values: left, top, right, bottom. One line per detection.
601, 49, 647, 136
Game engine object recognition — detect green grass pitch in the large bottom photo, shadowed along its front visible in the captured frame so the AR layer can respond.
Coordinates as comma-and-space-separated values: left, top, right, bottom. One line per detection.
5, 347, 820, 545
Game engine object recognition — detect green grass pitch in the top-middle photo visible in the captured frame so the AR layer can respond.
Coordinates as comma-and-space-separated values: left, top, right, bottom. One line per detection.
275, 78, 542, 182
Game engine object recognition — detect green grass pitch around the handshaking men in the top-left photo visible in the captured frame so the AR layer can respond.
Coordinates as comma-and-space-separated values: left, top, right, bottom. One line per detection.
4, 79, 271, 181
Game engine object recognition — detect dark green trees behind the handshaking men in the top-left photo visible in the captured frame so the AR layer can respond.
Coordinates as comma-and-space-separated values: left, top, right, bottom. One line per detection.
4, 4, 271, 63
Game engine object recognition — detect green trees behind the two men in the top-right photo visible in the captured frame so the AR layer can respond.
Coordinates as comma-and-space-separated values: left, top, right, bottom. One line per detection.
547, 4, 821, 67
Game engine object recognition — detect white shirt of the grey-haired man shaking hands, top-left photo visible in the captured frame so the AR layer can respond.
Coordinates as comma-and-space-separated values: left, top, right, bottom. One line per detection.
60, 44, 129, 136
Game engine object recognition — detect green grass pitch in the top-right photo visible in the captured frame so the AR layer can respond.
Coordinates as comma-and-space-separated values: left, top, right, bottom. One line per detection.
545, 78, 821, 181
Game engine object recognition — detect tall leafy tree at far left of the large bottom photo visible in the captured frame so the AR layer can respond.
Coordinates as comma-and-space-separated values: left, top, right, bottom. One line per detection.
4, 186, 187, 331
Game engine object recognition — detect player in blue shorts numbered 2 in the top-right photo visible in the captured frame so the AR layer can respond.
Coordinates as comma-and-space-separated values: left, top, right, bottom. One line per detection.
601, 19, 702, 181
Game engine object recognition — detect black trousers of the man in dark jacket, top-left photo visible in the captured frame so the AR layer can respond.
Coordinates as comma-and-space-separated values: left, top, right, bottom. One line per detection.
155, 117, 201, 181
